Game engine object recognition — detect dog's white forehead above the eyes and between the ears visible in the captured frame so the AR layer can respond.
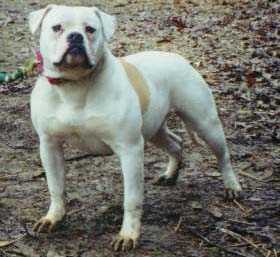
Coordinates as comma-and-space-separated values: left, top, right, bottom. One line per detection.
45, 6, 100, 28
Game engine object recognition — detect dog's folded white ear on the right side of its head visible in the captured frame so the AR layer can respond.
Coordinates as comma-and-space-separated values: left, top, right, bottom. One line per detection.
94, 7, 117, 41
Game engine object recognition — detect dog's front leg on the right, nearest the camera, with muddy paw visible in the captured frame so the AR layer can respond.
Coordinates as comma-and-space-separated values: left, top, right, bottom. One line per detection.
113, 136, 144, 251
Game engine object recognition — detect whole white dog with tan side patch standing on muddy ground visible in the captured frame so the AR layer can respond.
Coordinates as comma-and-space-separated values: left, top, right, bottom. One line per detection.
29, 5, 241, 250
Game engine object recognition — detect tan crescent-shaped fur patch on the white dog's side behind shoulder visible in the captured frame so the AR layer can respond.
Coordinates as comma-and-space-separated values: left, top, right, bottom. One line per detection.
120, 58, 150, 114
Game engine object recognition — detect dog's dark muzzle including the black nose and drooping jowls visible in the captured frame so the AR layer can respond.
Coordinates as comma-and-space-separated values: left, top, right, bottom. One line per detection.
54, 32, 92, 69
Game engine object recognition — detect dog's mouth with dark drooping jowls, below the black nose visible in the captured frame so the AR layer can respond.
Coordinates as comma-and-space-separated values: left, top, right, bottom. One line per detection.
54, 44, 92, 69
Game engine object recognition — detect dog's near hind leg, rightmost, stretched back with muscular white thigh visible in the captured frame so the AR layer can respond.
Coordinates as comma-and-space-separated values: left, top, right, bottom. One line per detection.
174, 75, 241, 198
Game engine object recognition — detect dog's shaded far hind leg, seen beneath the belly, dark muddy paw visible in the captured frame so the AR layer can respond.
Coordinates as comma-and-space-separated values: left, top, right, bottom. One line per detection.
151, 124, 182, 186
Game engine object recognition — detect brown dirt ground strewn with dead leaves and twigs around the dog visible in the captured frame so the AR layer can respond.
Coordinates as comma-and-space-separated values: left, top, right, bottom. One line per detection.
0, 0, 280, 257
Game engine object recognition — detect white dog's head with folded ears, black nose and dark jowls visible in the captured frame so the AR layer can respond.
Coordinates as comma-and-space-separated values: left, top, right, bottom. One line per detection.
29, 5, 116, 79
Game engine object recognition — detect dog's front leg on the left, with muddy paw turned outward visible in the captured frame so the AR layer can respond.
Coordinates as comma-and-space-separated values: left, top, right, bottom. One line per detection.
33, 136, 65, 232
